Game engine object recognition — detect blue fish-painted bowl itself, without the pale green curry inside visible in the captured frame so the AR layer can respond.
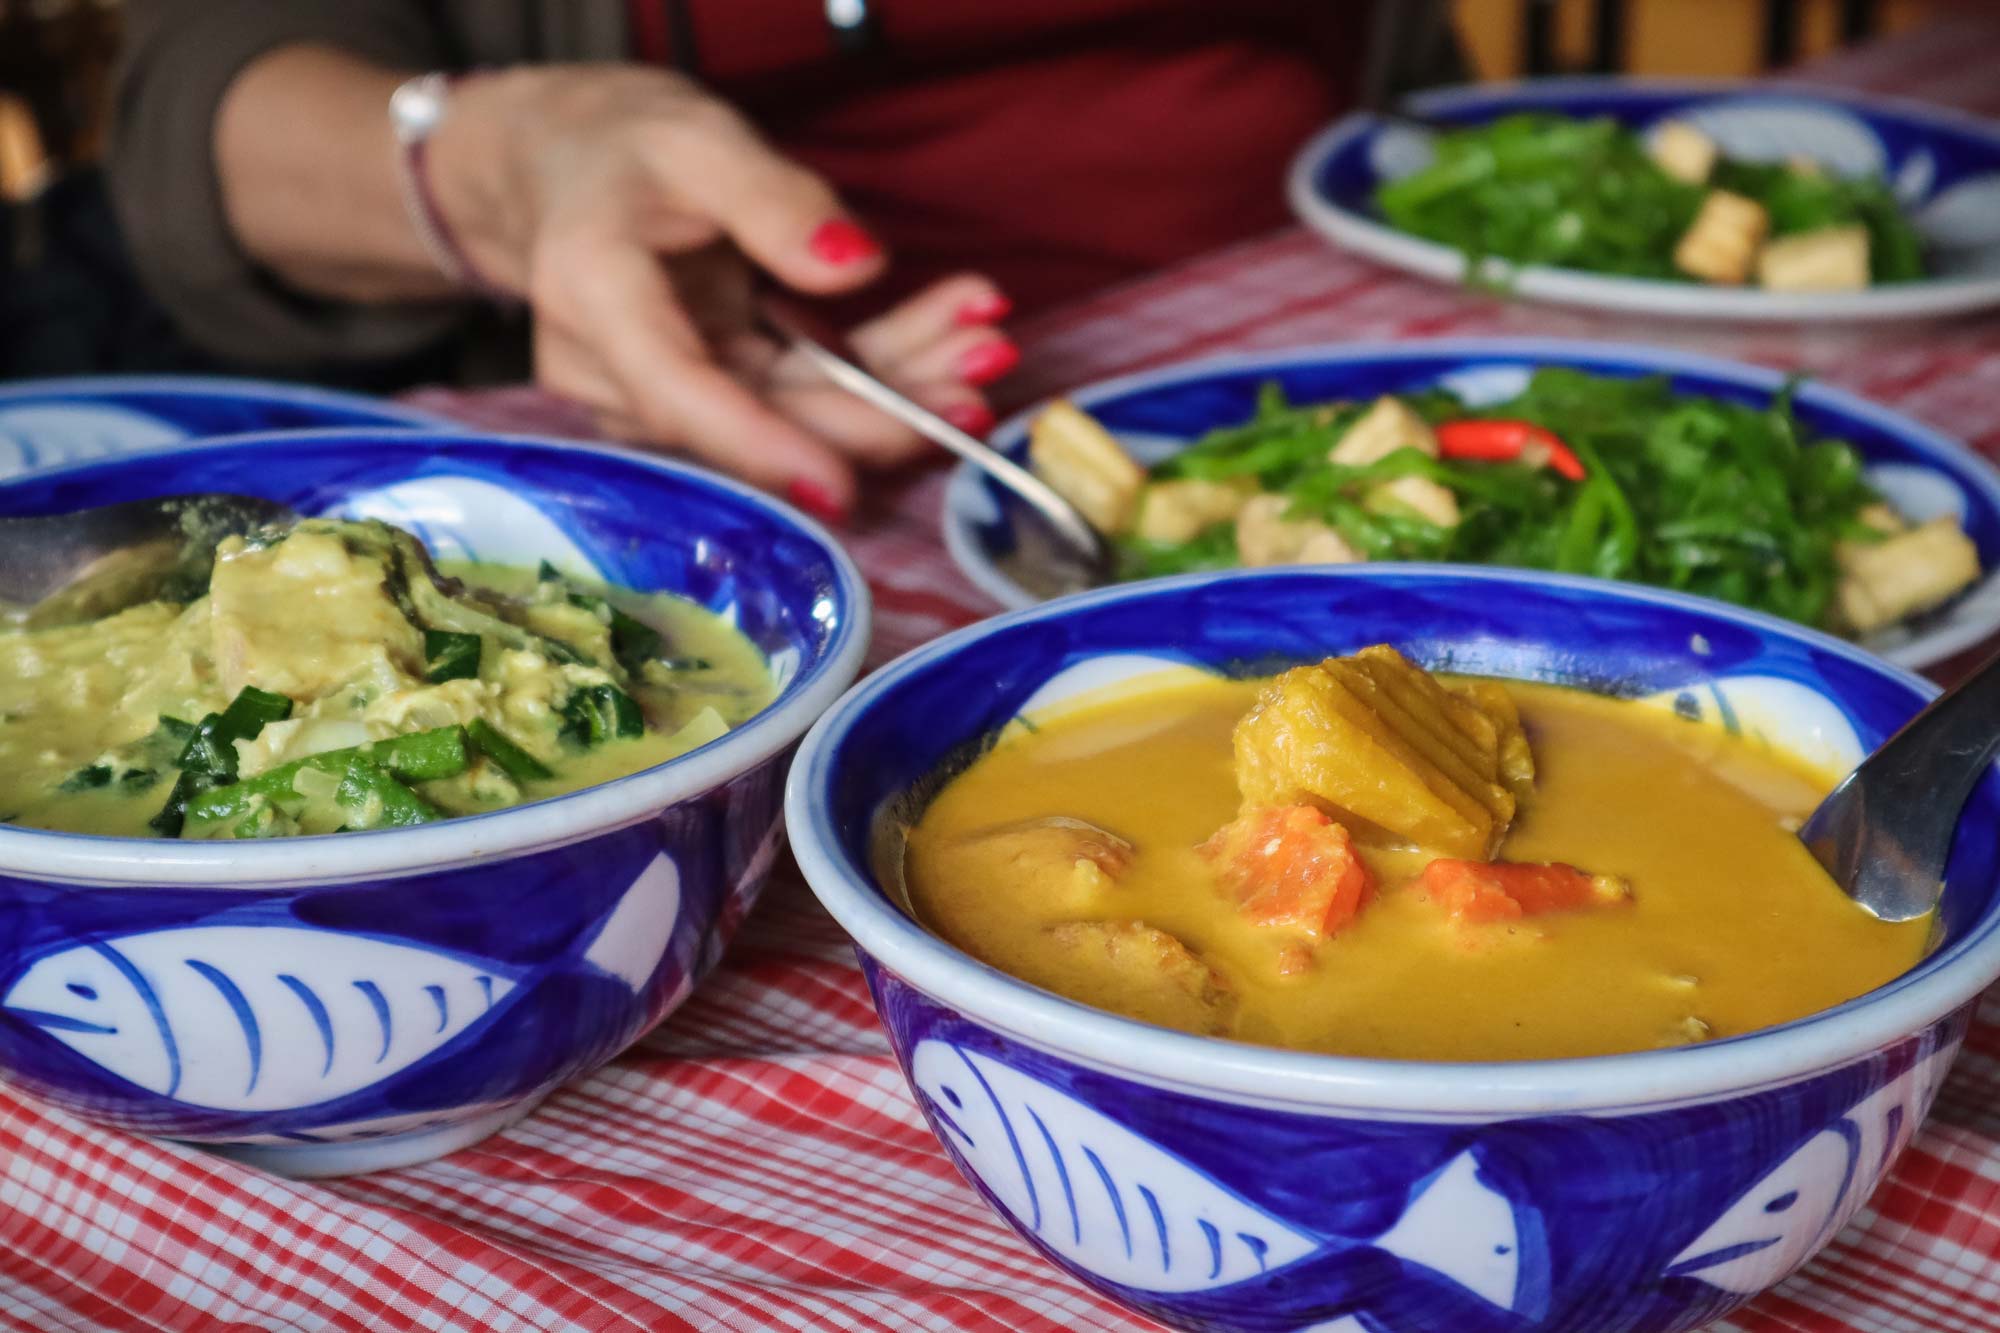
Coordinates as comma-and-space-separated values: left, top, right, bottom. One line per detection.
0, 430, 868, 1175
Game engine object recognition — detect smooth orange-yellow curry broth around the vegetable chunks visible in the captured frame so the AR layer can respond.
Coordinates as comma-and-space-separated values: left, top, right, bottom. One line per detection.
904, 681, 1930, 1061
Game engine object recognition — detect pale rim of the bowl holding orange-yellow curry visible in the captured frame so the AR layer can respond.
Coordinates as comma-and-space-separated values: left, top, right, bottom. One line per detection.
784, 562, 2000, 1119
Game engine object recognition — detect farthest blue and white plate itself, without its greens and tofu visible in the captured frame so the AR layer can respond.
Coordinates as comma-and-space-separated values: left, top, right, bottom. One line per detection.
1288, 78, 2000, 320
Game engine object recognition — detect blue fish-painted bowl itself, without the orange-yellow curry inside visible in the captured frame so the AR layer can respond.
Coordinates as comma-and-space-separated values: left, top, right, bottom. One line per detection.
786, 564, 2000, 1333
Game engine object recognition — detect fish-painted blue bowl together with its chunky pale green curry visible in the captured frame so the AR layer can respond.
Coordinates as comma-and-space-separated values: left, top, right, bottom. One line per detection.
0, 428, 868, 1175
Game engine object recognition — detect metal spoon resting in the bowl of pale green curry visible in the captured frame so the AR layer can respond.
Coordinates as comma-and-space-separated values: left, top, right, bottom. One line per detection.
0, 494, 298, 628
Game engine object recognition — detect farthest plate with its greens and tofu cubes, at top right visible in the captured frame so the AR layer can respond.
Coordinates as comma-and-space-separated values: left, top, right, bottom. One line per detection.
1286, 76, 2000, 322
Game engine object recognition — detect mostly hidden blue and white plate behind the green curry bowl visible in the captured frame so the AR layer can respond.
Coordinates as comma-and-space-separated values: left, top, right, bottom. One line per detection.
0, 374, 452, 478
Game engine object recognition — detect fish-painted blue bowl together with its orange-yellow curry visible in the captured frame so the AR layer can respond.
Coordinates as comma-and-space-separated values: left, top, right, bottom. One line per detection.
788, 564, 2000, 1333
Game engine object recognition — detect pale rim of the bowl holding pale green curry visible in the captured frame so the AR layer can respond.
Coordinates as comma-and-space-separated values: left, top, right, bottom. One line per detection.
0, 426, 872, 889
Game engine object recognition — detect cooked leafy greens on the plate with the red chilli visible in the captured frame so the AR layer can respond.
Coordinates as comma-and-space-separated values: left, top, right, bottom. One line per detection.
1118, 368, 1978, 632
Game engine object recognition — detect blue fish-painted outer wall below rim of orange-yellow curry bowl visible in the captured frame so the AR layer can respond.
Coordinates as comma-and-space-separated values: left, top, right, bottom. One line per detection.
884, 961, 1964, 1333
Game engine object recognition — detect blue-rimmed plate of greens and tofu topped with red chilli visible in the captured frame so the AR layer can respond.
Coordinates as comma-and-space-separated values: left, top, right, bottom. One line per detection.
944, 338, 2000, 664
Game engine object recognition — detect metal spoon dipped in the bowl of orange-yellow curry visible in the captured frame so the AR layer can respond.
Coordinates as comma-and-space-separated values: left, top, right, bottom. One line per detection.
1798, 654, 2000, 921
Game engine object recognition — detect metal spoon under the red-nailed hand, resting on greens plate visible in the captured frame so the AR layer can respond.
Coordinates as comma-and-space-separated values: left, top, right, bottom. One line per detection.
754, 298, 1112, 596
